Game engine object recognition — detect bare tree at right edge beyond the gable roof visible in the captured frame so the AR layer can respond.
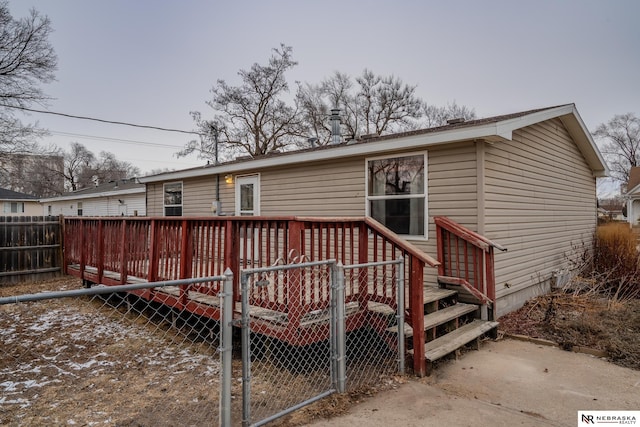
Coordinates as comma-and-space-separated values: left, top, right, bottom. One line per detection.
593, 113, 640, 183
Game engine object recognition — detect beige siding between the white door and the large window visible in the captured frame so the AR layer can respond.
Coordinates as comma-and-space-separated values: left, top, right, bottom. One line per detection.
260, 157, 365, 216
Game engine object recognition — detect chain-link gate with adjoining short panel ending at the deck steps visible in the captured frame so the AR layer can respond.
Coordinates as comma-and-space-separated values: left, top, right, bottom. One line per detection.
239, 260, 404, 427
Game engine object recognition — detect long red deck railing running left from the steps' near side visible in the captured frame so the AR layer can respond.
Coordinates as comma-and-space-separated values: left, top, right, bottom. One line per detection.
65, 217, 439, 371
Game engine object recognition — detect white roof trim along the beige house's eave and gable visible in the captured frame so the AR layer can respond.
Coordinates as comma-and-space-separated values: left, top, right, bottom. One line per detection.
138, 104, 608, 184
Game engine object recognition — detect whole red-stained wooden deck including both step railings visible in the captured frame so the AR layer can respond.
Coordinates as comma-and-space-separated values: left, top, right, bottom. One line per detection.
64, 217, 498, 375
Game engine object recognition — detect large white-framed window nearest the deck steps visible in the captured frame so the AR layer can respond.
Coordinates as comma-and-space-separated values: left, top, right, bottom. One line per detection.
367, 154, 427, 237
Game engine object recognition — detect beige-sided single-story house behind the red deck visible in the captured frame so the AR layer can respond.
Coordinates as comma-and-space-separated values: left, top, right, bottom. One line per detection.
140, 104, 608, 315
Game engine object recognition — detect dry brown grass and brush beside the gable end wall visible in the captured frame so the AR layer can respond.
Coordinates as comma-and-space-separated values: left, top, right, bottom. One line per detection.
499, 223, 640, 370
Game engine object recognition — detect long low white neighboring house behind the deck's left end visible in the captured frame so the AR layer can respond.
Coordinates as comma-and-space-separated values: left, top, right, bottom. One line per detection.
40, 178, 146, 216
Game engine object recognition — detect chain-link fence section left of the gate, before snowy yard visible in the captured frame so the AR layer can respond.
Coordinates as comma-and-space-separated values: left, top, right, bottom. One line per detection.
0, 276, 232, 426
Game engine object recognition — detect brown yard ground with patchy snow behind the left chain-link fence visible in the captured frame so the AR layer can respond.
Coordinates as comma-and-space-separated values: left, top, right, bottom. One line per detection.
0, 277, 240, 426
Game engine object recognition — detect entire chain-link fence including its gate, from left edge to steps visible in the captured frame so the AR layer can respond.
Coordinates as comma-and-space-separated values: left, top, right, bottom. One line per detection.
0, 260, 404, 426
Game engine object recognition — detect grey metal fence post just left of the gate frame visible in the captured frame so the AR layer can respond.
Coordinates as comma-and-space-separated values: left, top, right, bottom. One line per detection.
218, 268, 233, 427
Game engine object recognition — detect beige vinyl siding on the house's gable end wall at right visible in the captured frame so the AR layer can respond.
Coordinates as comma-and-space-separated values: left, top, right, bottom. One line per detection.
485, 119, 596, 314
